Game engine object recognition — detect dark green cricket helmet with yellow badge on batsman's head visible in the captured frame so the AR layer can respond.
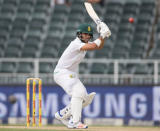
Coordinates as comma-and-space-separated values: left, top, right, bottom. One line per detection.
77, 23, 93, 42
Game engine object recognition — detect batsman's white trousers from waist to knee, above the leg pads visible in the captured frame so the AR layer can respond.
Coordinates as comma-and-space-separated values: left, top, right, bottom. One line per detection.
54, 69, 87, 100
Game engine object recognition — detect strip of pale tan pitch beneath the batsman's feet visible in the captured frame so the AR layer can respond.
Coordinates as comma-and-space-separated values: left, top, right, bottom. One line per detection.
0, 125, 160, 131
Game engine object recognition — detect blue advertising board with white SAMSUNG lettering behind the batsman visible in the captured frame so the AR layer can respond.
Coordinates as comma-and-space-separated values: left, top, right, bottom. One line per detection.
0, 86, 160, 125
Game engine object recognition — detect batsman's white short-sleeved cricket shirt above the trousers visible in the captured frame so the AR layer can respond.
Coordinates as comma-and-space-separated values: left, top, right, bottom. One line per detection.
56, 37, 86, 72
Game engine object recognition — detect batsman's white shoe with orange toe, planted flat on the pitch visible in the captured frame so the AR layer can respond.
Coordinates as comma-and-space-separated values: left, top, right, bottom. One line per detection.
68, 120, 88, 129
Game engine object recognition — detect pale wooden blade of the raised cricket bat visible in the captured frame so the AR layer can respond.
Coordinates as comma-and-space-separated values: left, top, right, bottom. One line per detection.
84, 2, 101, 24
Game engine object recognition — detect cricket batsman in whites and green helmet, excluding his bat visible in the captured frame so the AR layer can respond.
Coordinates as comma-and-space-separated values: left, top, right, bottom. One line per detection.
54, 22, 111, 129
